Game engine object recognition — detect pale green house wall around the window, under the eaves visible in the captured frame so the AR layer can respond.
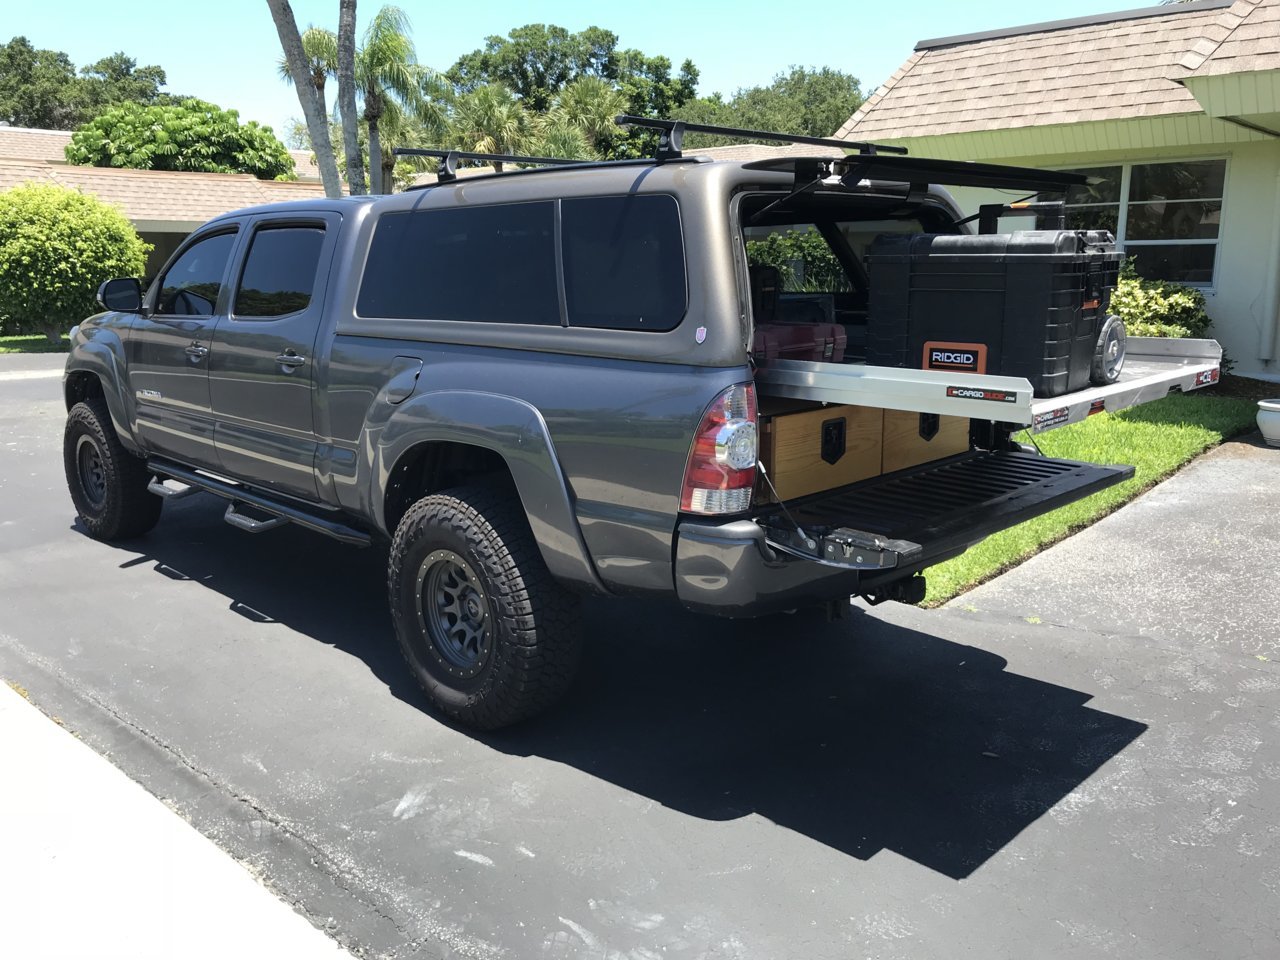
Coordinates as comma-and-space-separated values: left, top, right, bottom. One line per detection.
947, 140, 1280, 379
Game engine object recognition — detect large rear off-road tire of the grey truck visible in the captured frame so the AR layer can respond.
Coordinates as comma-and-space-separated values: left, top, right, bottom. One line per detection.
387, 485, 581, 730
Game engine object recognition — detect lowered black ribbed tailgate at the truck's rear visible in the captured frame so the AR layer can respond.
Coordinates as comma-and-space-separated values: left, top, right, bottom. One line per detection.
758, 451, 1134, 571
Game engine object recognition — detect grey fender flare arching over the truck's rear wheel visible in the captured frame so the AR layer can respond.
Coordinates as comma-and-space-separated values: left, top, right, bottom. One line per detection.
366, 390, 608, 594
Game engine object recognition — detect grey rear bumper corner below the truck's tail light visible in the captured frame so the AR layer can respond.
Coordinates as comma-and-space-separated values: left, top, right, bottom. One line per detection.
676, 520, 875, 617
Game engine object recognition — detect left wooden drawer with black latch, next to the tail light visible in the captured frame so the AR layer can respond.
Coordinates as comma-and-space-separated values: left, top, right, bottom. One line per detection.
760, 406, 885, 500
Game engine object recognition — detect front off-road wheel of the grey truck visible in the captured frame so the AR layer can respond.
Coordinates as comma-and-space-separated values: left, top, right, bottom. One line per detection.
63, 398, 164, 540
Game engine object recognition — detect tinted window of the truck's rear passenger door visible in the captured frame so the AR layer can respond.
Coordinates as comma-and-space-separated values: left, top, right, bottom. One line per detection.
232, 227, 324, 316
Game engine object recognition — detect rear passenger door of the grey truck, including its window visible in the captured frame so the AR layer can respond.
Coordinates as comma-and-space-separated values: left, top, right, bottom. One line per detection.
210, 212, 340, 500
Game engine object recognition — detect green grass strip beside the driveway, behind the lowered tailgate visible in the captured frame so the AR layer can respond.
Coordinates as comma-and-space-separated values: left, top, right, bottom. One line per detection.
924, 393, 1258, 605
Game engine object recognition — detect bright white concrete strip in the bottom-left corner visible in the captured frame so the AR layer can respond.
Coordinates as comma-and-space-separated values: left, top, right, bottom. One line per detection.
0, 684, 349, 960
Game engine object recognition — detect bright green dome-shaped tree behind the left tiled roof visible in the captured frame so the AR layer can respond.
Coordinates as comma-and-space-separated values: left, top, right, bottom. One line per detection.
67, 100, 293, 179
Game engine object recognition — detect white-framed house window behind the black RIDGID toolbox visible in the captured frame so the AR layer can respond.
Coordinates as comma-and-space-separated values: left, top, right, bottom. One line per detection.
1044, 160, 1226, 287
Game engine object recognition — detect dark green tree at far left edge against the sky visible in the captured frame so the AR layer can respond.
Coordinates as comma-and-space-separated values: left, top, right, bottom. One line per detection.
0, 37, 84, 131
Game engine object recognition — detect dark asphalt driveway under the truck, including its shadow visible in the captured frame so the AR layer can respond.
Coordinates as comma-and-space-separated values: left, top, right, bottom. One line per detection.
0, 357, 1280, 960
